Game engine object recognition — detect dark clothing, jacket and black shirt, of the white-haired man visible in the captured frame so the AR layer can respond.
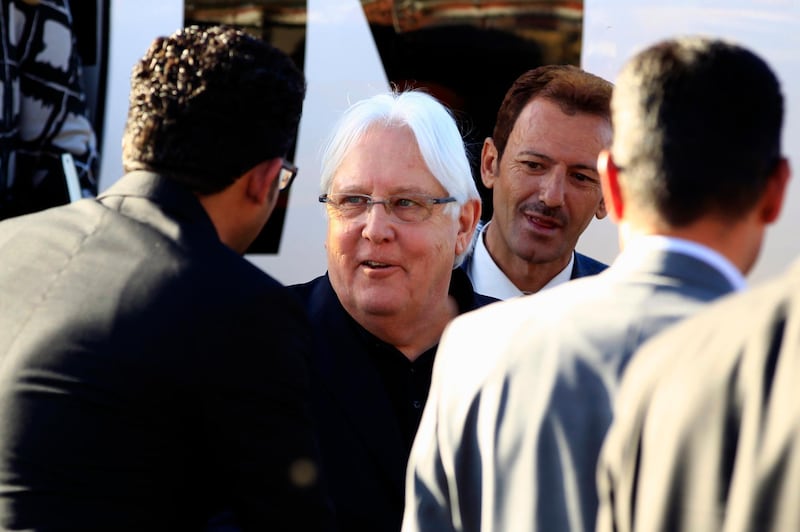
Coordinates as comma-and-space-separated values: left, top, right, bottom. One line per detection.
292, 269, 498, 532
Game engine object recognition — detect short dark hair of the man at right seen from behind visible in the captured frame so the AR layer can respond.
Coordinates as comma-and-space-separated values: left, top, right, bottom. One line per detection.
611, 37, 783, 227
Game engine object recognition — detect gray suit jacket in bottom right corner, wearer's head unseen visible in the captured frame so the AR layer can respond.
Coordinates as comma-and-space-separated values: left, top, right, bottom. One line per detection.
597, 263, 800, 532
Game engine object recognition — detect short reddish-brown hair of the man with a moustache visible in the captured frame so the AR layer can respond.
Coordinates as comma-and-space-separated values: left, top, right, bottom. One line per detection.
492, 65, 613, 158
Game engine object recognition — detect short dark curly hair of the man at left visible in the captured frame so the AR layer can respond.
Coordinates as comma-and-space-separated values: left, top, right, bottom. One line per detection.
123, 26, 306, 194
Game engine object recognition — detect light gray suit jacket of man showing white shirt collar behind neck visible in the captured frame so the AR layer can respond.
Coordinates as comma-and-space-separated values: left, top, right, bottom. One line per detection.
403, 244, 733, 532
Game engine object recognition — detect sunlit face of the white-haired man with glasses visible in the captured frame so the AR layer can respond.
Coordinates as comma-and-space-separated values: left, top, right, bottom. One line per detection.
326, 126, 471, 321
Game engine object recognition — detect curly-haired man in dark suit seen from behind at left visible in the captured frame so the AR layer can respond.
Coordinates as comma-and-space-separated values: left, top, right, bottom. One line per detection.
0, 27, 329, 531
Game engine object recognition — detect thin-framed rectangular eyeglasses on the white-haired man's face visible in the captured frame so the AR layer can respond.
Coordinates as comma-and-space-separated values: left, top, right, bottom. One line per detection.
319, 193, 456, 223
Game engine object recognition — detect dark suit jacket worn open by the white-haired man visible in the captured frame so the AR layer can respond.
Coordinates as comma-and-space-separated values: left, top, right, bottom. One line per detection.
292, 270, 497, 532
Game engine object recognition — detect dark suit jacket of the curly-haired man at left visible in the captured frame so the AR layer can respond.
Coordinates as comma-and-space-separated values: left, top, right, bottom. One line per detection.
0, 172, 334, 531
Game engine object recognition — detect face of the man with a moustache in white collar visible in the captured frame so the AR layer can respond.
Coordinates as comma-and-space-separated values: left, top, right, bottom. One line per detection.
481, 98, 611, 265
